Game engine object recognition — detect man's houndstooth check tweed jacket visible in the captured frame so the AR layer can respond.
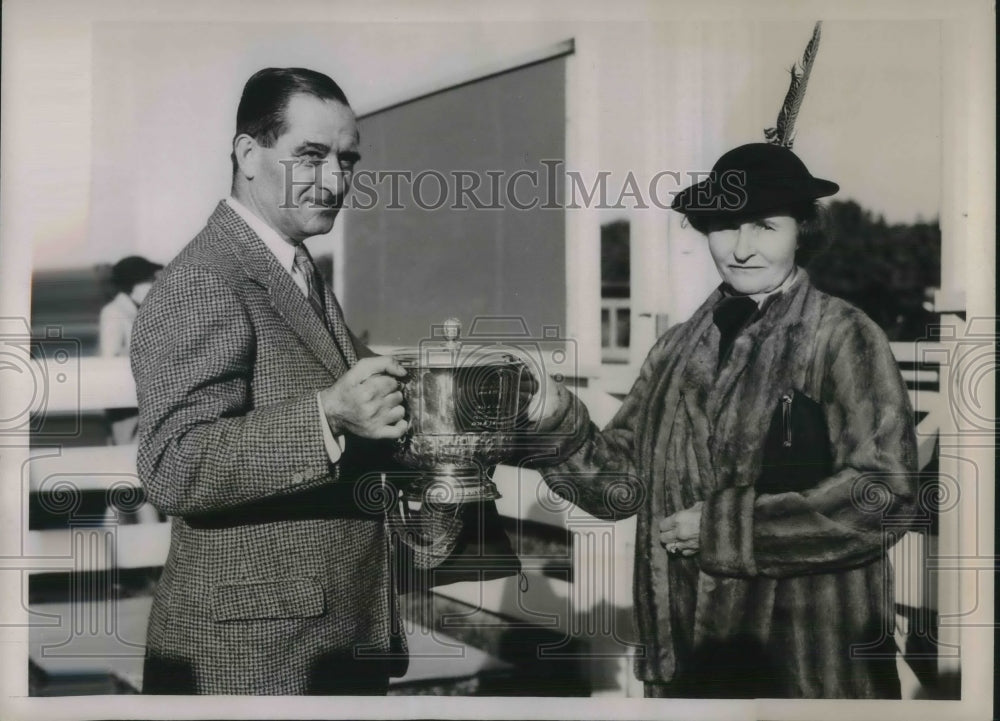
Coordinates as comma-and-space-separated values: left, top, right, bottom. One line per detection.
131, 203, 406, 694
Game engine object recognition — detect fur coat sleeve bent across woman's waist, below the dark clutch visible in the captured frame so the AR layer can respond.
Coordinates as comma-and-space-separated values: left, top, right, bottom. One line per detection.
699, 312, 917, 577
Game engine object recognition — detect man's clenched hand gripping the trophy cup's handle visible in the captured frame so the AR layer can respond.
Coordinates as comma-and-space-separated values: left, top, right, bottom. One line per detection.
319, 356, 407, 438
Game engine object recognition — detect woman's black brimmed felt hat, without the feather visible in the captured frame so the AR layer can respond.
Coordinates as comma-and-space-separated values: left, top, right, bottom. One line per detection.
670, 143, 840, 218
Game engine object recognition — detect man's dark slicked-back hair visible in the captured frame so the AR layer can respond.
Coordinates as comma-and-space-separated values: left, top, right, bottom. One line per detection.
230, 68, 351, 173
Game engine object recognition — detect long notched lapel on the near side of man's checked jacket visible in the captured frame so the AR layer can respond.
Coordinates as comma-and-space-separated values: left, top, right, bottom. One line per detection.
209, 201, 347, 376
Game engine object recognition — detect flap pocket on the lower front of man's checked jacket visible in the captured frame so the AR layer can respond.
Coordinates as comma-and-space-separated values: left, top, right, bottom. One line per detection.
211, 578, 326, 622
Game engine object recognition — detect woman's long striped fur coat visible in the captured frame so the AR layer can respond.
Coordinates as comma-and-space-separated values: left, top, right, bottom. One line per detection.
542, 270, 916, 698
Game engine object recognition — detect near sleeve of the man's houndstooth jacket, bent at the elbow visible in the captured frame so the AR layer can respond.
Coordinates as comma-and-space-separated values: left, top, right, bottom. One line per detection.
131, 266, 335, 516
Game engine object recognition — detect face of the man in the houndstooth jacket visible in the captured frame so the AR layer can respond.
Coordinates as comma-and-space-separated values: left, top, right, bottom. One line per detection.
249, 93, 360, 243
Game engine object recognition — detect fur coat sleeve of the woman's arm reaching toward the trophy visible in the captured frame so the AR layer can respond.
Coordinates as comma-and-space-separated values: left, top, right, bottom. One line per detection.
530, 336, 666, 520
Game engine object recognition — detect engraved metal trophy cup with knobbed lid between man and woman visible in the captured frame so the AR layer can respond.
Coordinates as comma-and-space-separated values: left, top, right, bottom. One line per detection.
394, 319, 526, 505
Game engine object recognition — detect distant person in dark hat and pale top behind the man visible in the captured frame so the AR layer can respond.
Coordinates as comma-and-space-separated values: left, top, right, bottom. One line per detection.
98, 255, 163, 446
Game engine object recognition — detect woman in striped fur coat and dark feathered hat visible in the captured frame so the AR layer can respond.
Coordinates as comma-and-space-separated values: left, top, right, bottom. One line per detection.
539, 143, 916, 698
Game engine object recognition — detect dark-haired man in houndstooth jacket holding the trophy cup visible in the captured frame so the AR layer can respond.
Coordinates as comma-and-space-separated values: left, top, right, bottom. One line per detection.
132, 68, 406, 694
